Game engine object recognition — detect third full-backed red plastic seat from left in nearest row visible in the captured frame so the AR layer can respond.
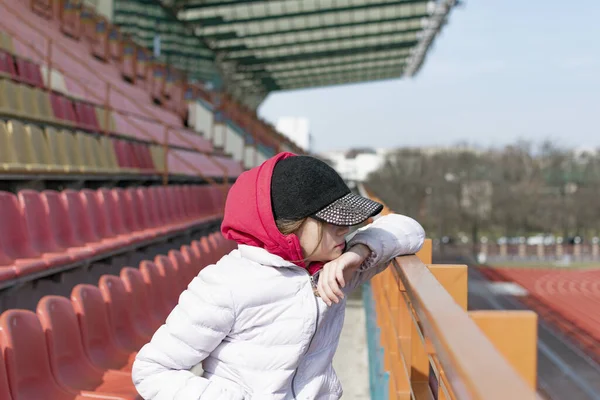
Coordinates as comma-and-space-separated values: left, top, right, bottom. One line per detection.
71, 284, 135, 372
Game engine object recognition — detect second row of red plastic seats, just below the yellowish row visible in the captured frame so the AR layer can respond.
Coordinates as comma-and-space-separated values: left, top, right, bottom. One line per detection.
0, 186, 224, 281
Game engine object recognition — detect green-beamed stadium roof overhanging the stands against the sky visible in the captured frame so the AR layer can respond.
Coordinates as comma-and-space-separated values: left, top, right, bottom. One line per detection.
115, 0, 457, 106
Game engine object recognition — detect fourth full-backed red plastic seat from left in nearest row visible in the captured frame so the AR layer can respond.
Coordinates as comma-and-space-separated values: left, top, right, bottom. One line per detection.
98, 275, 152, 351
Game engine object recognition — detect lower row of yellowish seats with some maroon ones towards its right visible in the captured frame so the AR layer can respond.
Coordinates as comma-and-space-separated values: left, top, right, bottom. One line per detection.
0, 120, 165, 175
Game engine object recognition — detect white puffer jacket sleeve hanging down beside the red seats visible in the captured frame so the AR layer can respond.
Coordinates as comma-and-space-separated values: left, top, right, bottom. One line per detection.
132, 266, 242, 400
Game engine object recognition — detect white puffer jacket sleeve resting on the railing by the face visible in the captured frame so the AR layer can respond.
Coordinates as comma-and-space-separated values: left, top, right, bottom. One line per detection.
348, 214, 425, 289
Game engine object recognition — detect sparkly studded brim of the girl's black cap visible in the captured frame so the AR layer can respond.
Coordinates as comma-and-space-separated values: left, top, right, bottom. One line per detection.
313, 193, 383, 226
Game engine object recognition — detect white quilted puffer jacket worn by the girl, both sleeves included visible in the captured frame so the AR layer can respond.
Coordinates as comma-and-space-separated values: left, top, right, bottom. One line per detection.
133, 214, 425, 400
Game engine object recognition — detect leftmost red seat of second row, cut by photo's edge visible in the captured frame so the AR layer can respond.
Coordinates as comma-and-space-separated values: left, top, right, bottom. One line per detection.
0, 192, 48, 276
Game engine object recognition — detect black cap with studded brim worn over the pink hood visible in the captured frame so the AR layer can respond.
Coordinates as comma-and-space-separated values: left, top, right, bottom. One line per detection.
271, 156, 383, 226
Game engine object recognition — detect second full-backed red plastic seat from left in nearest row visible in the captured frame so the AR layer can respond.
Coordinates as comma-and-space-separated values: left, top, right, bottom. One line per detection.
36, 296, 102, 389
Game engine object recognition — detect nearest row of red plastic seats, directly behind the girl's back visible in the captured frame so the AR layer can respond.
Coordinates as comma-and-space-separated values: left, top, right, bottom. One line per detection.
0, 233, 233, 400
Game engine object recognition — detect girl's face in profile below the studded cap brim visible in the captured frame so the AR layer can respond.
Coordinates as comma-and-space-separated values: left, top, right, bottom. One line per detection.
296, 218, 350, 263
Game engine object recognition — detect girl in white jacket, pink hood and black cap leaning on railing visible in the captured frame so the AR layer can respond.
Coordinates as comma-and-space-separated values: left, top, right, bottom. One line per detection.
133, 153, 425, 400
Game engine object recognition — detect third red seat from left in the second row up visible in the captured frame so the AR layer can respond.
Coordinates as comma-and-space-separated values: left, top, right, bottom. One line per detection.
42, 190, 94, 260
